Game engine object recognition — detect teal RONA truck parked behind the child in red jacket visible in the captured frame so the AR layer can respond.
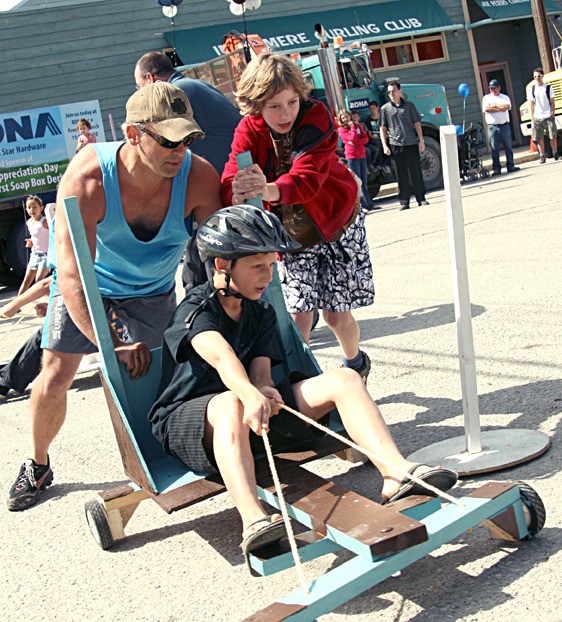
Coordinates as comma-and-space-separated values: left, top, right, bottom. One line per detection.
179, 26, 451, 197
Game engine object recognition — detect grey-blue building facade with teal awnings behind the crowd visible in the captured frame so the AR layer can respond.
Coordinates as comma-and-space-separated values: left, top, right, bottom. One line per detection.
0, 0, 562, 154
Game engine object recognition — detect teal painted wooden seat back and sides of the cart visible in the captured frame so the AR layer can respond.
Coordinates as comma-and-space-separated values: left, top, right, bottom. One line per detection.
64, 197, 328, 494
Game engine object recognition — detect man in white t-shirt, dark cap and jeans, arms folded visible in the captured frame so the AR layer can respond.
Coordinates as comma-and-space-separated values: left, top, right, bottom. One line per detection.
482, 80, 519, 176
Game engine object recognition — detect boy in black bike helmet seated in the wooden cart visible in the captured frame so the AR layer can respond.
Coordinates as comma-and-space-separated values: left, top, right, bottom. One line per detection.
149, 205, 457, 568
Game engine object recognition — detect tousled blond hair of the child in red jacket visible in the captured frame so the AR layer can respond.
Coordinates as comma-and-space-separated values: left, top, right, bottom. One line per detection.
236, 52, 309, 115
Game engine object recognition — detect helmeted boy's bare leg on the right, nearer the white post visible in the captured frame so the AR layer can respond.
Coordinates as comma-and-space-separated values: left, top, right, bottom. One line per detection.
293, 368, 423, 499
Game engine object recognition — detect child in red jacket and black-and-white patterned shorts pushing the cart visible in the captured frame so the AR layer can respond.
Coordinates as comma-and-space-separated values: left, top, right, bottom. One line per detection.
221, 53, 375, 378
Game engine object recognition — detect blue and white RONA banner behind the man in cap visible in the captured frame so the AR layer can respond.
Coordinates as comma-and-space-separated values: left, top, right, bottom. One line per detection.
0, 100, 105, 201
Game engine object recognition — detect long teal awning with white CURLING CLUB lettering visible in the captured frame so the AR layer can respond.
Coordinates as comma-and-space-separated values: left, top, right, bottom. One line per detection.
165, 0, 464, 65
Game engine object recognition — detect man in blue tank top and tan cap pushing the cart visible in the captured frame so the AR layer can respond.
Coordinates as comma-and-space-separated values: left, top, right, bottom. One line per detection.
8, 82, 221, 511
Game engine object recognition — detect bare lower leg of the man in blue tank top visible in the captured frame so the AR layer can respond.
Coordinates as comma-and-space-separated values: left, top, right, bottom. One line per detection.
31, 350, 82, 464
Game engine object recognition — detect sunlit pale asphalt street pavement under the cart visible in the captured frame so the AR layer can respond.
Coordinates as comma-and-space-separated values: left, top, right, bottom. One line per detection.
0, 156, 562, 622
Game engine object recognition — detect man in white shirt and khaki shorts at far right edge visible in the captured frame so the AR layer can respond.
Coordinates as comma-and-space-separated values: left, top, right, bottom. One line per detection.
529, 67, 560, 164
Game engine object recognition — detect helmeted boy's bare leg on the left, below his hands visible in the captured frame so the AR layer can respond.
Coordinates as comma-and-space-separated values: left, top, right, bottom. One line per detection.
205, 398, 281, 531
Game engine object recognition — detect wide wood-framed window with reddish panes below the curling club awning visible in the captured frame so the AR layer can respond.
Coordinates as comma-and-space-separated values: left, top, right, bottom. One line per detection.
369, 33, 448, 69
